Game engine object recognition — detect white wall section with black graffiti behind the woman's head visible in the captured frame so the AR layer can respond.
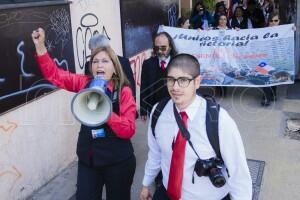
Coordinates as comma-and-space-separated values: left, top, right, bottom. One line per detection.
70, 0, 123, 73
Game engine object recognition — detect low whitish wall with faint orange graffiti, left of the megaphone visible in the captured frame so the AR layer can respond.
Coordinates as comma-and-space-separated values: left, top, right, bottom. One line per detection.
0, 90, 79, 200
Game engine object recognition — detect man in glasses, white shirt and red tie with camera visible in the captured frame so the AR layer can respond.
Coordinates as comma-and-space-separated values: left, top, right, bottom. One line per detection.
140, 54, 252, 200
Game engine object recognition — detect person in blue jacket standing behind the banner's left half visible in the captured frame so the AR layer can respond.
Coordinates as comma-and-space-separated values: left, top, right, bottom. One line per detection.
190, 2, 213, 30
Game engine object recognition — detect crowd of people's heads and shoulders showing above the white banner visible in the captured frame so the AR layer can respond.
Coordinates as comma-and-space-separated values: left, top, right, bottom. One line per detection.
177, 0, 276, 30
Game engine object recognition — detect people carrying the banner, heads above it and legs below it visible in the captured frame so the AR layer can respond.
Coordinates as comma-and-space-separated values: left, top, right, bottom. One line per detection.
177, 0, 295, 106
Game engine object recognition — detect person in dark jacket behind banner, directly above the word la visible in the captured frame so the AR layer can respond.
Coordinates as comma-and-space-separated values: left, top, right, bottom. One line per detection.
230, 7, 252, 29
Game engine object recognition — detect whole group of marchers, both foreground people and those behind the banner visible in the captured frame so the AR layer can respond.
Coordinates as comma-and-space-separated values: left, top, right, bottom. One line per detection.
32, 0, 294, 200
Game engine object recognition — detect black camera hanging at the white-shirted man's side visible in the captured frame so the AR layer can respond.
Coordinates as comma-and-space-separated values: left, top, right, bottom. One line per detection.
194, 158, 226, 188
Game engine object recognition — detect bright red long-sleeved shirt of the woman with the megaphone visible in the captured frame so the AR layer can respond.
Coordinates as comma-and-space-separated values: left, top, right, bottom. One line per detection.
36, 53, 136, 139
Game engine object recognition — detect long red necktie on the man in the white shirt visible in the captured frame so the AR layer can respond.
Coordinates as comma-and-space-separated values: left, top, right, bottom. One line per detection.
167, 112, 188, 200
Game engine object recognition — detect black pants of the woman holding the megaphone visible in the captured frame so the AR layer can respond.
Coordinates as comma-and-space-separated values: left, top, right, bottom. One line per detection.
76, 156, 136, 200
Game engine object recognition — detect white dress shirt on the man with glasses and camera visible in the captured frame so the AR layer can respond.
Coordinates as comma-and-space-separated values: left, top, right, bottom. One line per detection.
143, 96, 252, 200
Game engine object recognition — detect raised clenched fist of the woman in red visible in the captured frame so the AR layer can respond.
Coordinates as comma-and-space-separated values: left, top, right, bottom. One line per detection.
31, 28, 47, 56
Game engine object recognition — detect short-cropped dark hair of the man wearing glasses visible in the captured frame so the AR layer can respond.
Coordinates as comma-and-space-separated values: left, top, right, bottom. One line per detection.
167, 53, 200, 77
